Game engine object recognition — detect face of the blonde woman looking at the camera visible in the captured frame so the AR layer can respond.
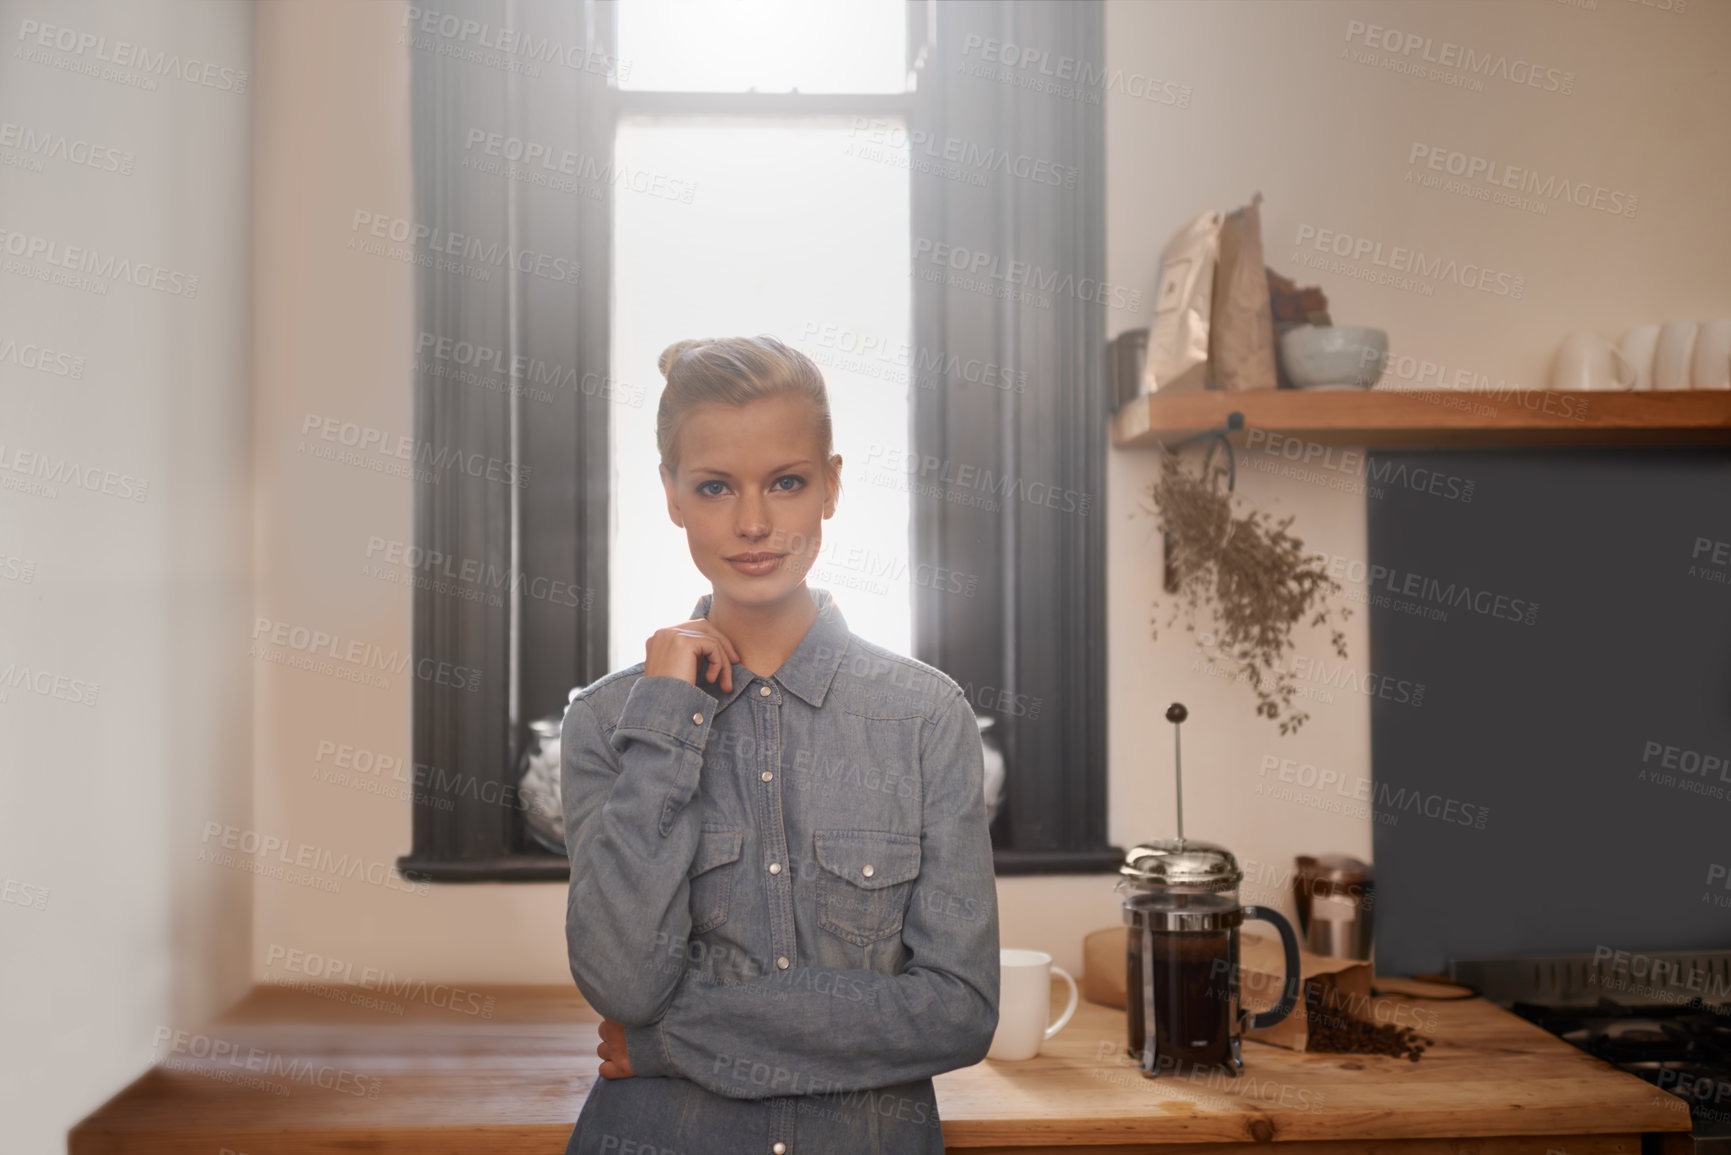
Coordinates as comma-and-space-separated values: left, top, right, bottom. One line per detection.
661, 393, 841, 604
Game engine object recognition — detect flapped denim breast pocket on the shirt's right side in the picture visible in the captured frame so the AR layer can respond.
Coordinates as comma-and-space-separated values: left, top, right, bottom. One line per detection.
812, 829, 919, 947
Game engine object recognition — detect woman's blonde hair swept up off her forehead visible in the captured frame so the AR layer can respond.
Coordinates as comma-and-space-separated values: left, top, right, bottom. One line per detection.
654, 334, 841, 490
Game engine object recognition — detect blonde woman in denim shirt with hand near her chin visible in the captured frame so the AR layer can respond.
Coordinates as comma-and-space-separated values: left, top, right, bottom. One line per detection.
561, 336, 999, 1155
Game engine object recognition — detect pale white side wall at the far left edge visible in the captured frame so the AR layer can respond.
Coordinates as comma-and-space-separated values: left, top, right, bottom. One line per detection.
0, 0, 253, 1153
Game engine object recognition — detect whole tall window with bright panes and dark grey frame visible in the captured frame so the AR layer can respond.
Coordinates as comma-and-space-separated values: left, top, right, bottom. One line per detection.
398, 0, 1122, 881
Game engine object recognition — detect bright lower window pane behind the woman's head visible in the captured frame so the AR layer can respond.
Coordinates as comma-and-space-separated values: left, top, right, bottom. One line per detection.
609, 117, 912, 668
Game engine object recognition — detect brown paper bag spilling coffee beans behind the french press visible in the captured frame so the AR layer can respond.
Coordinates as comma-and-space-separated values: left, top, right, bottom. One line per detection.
1082, 926, 1374, 1051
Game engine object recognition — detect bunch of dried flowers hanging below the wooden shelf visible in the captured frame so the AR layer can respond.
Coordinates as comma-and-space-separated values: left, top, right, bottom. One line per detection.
1149, 452, 1352, 734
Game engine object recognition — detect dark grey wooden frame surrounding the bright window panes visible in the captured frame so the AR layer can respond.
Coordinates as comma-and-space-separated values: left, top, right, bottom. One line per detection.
398, 0, 1122, 881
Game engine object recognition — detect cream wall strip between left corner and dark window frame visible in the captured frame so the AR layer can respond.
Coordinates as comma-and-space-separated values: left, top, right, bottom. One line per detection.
253, 0, 571, 982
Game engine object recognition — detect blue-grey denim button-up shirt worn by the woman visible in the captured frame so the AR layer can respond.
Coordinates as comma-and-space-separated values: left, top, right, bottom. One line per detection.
561, 585, 999, 1155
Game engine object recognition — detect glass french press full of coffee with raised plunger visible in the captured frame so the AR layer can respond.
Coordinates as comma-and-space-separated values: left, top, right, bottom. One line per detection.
1116, 701, 1302, 1079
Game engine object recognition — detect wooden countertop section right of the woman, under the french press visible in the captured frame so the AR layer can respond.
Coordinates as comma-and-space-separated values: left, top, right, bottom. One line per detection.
936, 982, 1689, 1155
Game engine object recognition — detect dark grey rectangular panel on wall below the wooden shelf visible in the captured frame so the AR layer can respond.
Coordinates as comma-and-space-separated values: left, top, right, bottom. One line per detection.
1354, 448, 1731, 975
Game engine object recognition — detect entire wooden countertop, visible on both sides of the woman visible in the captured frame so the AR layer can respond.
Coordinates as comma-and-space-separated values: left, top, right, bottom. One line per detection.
68, 985, 1689, 1155
